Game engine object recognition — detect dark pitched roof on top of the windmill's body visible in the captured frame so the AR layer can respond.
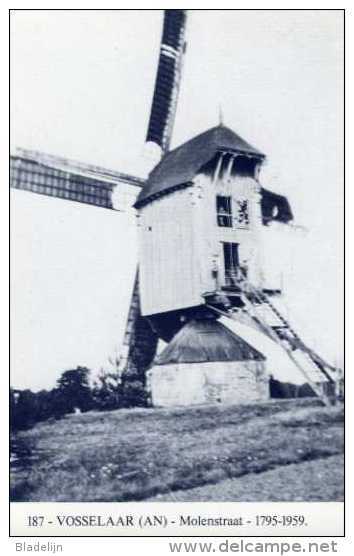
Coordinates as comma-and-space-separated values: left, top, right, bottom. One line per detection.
135, 125, 265, 208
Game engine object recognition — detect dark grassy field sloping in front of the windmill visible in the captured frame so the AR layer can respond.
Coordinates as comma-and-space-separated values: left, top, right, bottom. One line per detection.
12, 399, 343, 502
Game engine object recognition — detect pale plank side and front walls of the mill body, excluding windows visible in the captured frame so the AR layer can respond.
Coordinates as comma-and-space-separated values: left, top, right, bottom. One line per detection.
138, 174, 282, 315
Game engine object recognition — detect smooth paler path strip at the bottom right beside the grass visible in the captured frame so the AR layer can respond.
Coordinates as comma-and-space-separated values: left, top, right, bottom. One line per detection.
149, 456, 344, 502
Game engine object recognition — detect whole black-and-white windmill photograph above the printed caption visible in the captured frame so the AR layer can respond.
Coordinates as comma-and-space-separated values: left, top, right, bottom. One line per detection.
10, 9, 345, 535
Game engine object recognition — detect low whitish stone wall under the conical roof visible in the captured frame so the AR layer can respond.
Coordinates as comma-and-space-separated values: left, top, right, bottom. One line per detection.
147, 361, 270, 407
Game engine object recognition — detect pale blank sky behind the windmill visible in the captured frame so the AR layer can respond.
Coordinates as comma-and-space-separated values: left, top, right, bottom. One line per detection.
11, 10, 343, 389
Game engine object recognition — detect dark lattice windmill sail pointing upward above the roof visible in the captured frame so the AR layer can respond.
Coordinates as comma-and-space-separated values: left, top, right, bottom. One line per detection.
146, 10, 187, 153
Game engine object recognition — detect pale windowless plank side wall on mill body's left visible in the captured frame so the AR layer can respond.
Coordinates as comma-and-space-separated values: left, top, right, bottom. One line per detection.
139, 188, 200, 315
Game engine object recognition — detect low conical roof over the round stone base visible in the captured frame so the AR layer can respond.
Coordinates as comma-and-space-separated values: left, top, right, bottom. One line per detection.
154, 319, 265, 365
